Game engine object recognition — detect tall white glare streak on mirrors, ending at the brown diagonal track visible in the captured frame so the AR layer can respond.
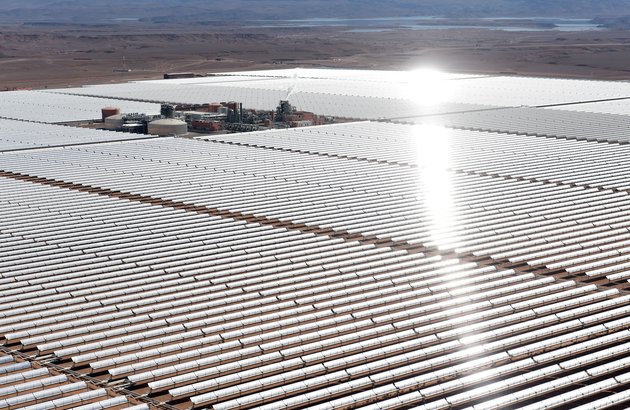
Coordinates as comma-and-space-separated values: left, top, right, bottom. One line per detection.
413, 125, 457, 249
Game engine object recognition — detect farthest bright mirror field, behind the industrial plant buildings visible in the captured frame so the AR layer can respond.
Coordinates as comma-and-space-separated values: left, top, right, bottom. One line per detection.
44, 69, 630, 119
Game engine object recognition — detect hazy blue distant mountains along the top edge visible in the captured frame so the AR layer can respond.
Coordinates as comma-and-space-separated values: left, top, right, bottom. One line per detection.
0, 0, 630, 24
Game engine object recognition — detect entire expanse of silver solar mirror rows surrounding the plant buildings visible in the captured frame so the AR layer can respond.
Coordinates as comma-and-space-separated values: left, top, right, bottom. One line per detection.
0, 70, 630, 410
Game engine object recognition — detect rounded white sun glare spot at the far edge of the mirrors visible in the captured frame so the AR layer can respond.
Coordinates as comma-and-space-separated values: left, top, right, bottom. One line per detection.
402, 68, 453, 106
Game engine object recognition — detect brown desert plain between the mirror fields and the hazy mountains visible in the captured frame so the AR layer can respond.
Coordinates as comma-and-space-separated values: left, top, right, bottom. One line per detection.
0, 25, 630, 90
